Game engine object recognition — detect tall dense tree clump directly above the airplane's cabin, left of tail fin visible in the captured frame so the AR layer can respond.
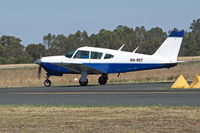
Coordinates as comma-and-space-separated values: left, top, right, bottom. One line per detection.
44, 25, 166, 55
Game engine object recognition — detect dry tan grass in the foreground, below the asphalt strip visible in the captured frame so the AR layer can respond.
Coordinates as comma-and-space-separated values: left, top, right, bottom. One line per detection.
0, 105, 200, 133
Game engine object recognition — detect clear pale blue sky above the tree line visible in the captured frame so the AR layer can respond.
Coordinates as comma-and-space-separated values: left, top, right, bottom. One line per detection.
0, 0, 200, 45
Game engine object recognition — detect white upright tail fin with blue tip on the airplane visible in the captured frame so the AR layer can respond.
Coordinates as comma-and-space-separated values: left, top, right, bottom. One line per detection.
153, 31, 184, 61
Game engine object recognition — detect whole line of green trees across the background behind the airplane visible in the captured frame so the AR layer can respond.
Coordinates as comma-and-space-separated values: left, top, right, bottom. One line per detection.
0, 19, 200, 64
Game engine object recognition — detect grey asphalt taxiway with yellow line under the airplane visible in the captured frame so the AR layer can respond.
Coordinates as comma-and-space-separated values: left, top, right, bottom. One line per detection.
0, 83, 200, 106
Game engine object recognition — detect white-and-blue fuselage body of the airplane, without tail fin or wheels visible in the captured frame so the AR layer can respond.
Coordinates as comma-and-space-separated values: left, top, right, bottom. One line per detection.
41, 47, 177, 76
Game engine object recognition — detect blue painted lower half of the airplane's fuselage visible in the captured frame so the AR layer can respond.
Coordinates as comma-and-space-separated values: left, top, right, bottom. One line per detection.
42, 63, 177, 76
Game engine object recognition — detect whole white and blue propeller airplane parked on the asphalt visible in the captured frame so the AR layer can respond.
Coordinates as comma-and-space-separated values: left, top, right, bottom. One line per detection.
36, 31, 184, 87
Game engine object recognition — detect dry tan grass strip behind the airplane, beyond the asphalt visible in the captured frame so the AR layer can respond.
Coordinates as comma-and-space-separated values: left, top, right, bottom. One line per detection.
0, 57, 200, 87
